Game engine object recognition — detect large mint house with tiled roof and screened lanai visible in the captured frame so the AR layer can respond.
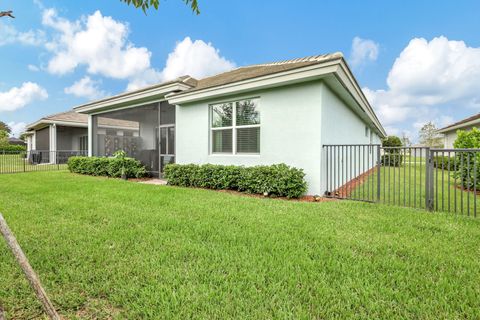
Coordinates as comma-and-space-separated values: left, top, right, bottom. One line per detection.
74, 53, 386, 194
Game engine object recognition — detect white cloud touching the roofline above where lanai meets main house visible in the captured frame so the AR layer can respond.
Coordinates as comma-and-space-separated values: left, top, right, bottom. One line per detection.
128, 37, 235, 90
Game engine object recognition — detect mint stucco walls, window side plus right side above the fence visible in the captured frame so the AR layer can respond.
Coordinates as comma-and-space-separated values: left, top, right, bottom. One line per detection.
175, 81, 378, 194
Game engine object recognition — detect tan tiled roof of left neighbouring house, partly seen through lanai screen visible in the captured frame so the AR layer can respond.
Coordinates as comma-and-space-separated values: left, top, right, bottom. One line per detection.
27, 110, 139, 130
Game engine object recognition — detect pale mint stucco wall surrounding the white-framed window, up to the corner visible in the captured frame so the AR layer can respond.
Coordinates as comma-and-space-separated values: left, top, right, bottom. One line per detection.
176, 82, 323, 193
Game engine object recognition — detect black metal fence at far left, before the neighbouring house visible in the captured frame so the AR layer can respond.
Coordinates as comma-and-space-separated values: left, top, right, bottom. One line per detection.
0, 150, 87, 174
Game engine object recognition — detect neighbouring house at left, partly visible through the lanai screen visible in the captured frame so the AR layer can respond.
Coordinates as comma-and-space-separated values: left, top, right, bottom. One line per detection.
25, 110, 138, 163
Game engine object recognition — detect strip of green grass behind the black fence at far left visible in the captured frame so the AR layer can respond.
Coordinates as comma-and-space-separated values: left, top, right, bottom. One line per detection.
0, 151, 67, 174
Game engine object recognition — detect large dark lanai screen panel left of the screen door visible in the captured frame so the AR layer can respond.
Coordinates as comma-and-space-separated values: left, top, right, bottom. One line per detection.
93, 103, 159, 175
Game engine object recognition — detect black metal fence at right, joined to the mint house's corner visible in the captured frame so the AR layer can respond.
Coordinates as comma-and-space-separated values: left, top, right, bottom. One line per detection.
323, 145, 480, 216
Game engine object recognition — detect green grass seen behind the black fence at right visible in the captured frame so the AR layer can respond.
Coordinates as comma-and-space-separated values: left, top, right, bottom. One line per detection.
350, 157, 480, 216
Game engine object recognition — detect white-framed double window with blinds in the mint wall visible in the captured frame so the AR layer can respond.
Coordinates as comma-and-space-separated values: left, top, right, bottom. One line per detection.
210, 99, 260, 154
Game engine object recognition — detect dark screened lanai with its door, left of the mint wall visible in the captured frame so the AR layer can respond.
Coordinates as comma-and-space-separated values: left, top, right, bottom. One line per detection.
92, 101, 175, 176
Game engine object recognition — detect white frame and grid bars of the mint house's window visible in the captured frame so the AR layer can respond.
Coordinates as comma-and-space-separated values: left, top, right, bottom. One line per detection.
208, 97, 262, 156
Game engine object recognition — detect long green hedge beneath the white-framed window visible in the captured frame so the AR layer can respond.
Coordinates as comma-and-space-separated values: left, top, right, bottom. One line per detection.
165, 164, 307, 198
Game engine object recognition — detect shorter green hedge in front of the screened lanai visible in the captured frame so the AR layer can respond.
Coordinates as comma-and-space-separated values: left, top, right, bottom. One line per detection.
67, 157, 147, 178
